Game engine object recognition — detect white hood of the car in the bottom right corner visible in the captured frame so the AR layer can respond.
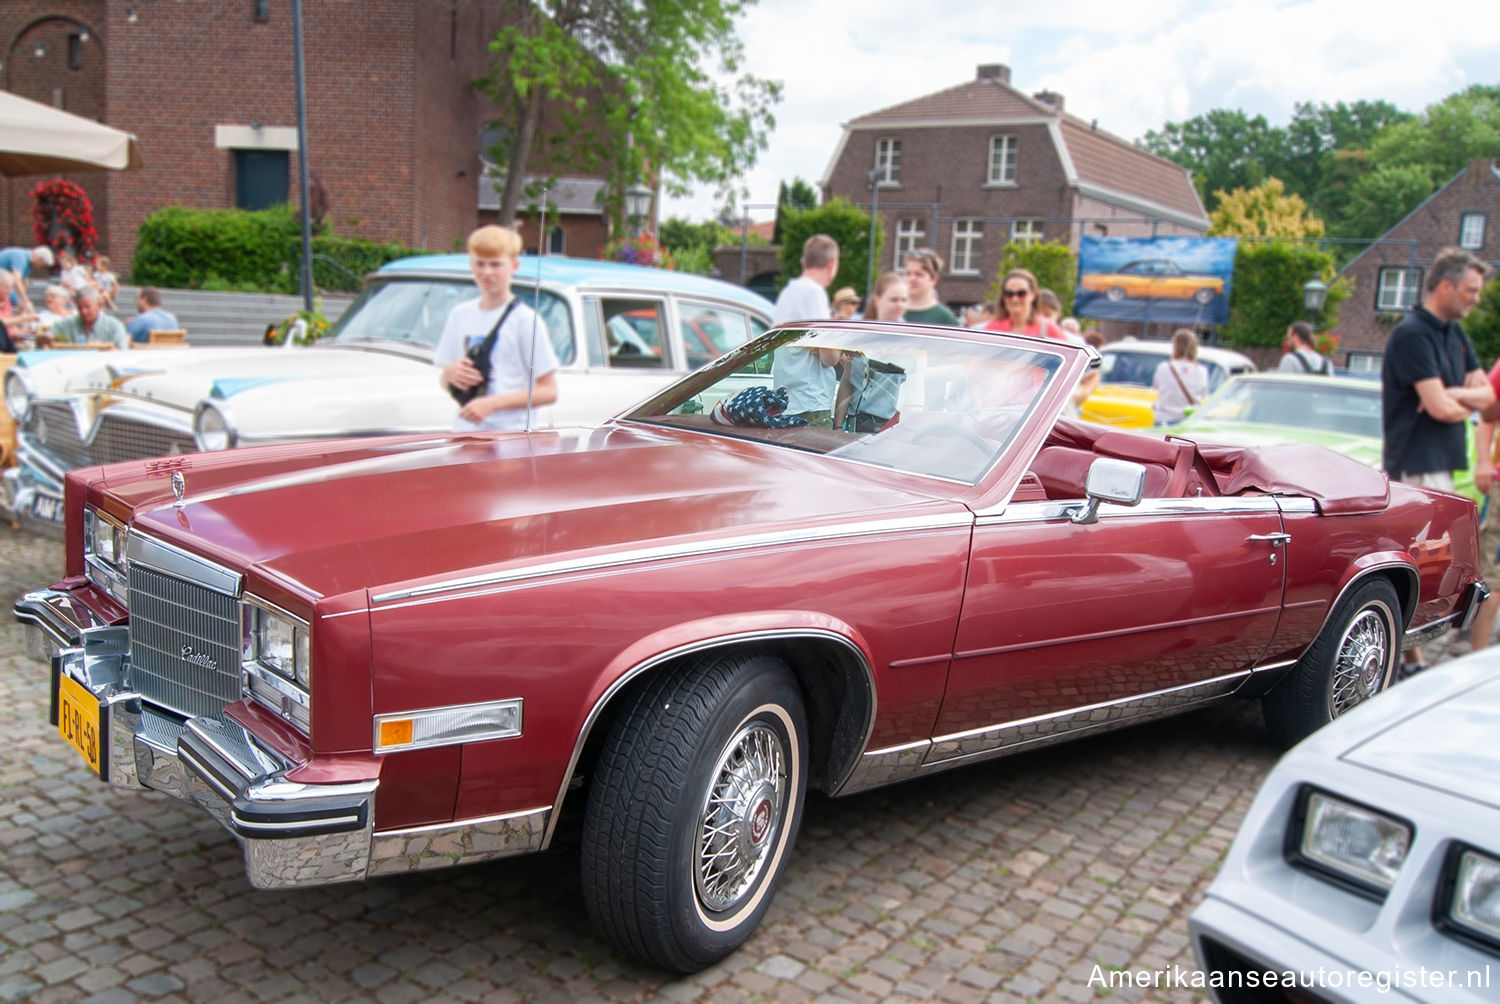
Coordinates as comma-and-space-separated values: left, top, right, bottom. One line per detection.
1340, 653, 1500, 809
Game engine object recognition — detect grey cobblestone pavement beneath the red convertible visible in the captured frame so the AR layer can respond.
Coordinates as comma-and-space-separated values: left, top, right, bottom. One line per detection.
0, 528, 1440, 1004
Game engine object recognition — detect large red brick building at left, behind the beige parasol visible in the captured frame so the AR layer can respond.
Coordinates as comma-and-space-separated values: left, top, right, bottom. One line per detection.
0, 0, 606, 270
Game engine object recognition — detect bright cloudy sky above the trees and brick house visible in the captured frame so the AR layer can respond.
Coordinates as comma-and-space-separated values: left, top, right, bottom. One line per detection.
663, 0, 1500, 219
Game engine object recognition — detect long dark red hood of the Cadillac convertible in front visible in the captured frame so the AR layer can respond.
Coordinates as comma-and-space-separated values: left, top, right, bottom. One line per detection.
104, 425, 968, 599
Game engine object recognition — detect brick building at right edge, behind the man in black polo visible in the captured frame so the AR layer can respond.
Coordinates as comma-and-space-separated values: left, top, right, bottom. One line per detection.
1338, 159, 1500, 371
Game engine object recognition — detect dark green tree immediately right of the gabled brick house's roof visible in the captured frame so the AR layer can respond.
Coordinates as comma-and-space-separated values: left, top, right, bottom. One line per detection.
1140, 108, 1287, 212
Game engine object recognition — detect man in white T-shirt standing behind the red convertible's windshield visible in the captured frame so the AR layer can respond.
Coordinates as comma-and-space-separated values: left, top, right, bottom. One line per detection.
771, 234, 839, 428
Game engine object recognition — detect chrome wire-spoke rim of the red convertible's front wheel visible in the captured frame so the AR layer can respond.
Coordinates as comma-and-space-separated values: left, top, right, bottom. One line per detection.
695, 723, 788, 912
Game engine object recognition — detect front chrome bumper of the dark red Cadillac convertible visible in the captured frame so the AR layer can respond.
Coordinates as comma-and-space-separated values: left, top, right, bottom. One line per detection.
15, 590, 378, 888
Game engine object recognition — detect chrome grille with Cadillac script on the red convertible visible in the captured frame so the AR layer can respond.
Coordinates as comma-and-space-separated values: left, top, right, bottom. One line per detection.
129, 561, 242, 717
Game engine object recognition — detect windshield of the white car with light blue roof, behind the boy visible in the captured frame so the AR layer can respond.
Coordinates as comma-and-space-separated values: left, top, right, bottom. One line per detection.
333, 278, 573, 365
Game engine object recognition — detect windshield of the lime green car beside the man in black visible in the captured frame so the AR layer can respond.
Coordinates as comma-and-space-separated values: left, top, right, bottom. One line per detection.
1193, 378, 1382, 438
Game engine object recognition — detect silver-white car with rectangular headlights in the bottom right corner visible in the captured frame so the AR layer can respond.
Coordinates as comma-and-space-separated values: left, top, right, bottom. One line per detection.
1190, 648, 1500, 1004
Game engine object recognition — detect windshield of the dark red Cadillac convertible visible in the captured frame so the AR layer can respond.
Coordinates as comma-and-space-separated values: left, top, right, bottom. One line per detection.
624, 327, 1064, 485
